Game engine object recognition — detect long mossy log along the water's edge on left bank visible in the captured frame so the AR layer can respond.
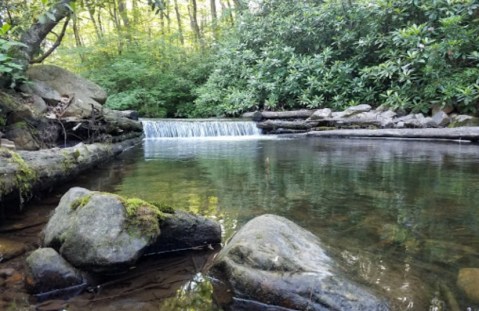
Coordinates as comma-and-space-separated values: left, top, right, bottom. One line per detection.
0, 137, 141, 210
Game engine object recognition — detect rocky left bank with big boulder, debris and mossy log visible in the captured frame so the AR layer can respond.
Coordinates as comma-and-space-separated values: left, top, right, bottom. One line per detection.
0, 65, 143, 214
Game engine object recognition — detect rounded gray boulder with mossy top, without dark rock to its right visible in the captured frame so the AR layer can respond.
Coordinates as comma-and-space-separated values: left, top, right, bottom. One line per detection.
44, 188, 160, 271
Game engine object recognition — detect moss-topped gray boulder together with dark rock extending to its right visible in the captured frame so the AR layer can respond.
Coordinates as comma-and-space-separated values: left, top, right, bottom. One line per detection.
44, 187, 221, 272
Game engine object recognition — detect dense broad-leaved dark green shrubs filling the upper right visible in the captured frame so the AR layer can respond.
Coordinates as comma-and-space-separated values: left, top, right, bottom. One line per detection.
196, 0, 479, 115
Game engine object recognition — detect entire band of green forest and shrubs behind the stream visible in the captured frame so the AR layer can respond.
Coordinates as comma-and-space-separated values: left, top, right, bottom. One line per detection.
0, 0, 479, 117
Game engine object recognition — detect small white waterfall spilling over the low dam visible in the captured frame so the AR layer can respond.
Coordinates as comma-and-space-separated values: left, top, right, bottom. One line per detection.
142, 120, 261, 139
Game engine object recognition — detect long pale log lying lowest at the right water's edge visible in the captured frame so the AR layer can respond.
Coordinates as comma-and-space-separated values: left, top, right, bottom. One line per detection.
307, 127, 479, 142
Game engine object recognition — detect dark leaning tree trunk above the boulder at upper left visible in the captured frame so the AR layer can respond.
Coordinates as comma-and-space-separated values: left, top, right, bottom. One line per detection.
15, 0, 75, 71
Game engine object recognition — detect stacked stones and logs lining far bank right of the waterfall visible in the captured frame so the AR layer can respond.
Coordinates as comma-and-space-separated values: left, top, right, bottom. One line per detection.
243, 104, 479, 142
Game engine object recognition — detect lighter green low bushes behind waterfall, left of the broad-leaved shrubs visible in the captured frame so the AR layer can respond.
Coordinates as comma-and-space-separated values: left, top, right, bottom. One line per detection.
55, 39, 209, 117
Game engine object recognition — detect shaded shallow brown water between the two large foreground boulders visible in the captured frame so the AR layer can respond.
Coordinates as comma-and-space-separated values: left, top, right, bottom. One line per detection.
35, 250, 218, 311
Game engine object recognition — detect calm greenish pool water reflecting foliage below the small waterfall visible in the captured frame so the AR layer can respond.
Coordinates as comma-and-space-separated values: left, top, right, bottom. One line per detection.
0, 138, 479, 310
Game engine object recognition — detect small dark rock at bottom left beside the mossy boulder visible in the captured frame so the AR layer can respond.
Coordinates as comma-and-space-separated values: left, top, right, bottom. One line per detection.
25, 248, 86, 294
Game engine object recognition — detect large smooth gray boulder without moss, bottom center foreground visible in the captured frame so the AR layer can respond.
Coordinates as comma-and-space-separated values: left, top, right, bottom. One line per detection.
211, 215, 389, 310
